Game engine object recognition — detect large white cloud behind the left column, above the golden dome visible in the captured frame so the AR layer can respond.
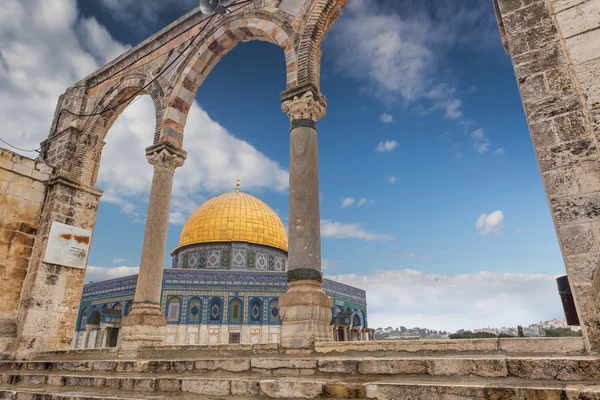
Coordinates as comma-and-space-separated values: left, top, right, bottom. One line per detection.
98, 96, 289, 225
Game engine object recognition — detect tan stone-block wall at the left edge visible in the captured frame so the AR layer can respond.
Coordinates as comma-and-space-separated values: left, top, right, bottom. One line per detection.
0, 149, 52, 351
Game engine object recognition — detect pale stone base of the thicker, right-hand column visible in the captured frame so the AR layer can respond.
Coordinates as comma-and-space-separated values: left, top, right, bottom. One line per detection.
279, 279, 333, 349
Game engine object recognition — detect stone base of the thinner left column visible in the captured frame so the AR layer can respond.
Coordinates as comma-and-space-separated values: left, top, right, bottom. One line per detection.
121, 303, 167, 352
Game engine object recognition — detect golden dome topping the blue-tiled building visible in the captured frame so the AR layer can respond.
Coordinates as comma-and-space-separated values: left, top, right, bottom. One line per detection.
178, 191, 288, 251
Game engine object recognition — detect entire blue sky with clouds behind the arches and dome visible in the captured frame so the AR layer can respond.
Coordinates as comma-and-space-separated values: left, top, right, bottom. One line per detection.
0, 0, 564, 330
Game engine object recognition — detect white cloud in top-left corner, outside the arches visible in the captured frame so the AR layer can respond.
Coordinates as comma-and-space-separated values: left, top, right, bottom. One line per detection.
0, 0, 128, 157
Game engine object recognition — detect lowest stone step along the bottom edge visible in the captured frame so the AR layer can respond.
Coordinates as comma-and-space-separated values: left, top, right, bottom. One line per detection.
0, 379, 600, 400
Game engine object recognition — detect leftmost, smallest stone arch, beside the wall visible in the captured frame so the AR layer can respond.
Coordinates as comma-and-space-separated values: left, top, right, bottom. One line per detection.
72, 74, 168, 186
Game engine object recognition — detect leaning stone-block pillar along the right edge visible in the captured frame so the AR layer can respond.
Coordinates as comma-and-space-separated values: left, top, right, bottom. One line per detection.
495, 0, 600, 353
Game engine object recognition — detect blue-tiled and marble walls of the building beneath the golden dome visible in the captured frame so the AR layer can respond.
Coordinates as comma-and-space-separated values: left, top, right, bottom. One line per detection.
72, 266, 367, 348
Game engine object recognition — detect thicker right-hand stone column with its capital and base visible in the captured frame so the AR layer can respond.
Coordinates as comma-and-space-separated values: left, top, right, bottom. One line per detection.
279, 85, 333, 348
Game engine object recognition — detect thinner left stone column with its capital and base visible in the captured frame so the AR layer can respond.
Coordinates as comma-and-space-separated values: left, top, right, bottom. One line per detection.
121, 143, 186, 351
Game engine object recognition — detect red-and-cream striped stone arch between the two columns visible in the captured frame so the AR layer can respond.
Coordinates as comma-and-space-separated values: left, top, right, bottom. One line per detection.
164, 11, 298, 147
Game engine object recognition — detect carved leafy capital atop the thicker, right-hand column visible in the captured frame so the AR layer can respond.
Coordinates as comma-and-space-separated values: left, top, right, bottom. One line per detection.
281, 85, 327, 122
